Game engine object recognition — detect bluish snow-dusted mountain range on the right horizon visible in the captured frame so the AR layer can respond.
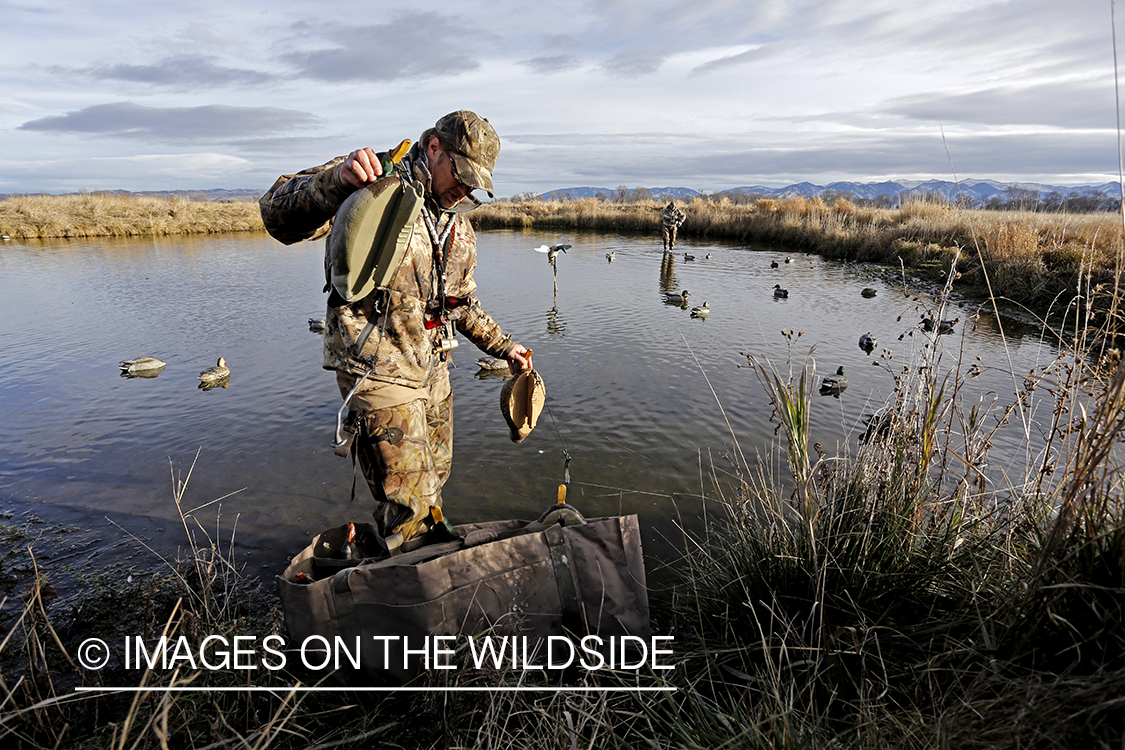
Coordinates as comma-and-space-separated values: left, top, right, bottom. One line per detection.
541, 180, 1121, 202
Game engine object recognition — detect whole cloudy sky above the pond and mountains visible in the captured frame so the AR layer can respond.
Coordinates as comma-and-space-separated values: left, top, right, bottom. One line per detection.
0, 0, 1125, 196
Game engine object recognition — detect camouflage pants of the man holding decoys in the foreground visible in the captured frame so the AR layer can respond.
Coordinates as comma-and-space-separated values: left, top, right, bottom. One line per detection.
342, 382, 453, 541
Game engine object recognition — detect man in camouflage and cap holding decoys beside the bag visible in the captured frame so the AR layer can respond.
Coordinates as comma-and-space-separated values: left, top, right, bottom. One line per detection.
260, 110, 532, 548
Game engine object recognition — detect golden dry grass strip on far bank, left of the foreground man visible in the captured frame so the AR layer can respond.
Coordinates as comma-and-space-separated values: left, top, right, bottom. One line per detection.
0, 193, 263, 240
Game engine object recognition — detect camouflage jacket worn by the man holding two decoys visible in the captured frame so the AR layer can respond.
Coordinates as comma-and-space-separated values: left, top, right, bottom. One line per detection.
259, 144, 512, 388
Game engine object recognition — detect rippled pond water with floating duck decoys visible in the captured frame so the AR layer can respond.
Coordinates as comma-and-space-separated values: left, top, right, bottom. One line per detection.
0, 231, 1054, 575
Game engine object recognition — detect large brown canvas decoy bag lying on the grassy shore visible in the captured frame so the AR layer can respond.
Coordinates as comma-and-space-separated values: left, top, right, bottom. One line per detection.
277, 505, 650, 684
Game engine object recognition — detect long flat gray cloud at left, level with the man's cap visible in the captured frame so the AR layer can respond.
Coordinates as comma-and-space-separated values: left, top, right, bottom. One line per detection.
17, 101, 321, 143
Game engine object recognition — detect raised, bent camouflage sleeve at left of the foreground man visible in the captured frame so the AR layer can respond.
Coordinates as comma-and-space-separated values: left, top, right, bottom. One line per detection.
258, 156, 352, 245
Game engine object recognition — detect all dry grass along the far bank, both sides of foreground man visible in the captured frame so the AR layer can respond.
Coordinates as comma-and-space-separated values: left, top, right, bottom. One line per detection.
0, 193, 1122, 314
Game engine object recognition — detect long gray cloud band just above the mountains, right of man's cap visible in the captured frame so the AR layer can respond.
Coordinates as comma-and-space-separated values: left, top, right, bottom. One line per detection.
495, 132, 1117, 192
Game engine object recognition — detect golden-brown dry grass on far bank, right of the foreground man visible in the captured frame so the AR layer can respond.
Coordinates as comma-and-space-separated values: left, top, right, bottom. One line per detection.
474, 197, 1122, 310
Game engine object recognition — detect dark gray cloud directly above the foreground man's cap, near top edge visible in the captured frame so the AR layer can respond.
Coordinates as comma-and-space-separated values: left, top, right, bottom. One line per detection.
280, 13, 491, 82
